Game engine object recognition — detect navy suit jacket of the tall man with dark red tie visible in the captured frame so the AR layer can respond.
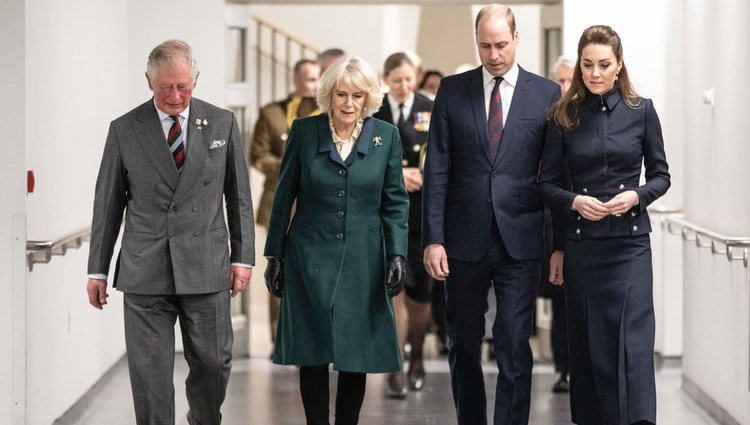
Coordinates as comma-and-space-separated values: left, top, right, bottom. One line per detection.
422, 66, 560, 261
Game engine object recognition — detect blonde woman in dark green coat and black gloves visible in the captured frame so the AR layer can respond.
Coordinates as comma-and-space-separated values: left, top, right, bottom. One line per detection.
265, 58, 409, 425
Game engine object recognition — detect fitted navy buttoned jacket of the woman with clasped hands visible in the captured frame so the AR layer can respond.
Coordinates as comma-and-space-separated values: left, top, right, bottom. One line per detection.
540, 87, 670, 245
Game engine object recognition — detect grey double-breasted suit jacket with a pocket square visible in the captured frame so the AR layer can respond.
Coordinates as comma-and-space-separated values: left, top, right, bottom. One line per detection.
88, 98, 255, 294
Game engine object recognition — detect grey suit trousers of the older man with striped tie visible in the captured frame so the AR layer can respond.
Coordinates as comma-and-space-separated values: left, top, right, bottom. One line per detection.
124, 291, 234, 425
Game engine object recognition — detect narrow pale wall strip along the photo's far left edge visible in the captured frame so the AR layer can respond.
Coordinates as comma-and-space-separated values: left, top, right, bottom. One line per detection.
0, 0, 26, 424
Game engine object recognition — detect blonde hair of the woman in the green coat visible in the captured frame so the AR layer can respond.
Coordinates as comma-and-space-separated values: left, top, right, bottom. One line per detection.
317, 56, 383, 118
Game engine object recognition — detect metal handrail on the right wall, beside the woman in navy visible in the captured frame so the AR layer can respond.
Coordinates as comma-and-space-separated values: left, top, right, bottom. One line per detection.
664, 215, 750, 268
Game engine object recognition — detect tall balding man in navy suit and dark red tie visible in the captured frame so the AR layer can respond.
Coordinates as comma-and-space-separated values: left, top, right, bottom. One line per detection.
422, 5, 560, 425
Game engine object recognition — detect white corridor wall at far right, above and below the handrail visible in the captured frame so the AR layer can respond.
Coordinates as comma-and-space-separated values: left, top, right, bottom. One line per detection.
683, 0, 750, 424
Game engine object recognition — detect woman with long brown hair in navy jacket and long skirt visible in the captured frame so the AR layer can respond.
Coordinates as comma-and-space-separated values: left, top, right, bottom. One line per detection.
540, 26, 670, 424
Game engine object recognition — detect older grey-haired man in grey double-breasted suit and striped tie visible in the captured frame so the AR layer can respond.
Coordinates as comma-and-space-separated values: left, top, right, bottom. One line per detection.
87, 40, 255, 425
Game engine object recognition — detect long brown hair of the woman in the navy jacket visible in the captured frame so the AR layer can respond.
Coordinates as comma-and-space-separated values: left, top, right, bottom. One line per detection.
552, 25, 641, 130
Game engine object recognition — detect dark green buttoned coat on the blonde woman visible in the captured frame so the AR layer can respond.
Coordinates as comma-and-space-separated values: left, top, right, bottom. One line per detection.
265, 114, 409, 373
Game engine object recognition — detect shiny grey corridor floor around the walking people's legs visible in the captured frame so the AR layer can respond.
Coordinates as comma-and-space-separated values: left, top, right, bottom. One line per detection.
66, 358, 716, 425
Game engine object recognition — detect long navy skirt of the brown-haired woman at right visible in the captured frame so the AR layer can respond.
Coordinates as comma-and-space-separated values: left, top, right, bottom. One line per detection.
563, 235, 656, 425
